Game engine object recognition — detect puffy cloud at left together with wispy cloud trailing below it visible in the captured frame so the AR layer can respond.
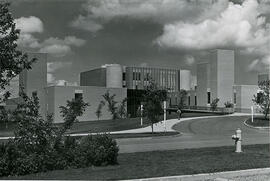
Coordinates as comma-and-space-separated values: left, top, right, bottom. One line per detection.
15, 16, 85, 57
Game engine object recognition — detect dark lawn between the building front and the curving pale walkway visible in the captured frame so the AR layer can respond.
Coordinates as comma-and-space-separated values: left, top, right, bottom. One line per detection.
0, 112, 217, 136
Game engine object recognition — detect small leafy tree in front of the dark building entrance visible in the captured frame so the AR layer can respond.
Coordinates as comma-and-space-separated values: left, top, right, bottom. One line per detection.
143, 80, 167, 133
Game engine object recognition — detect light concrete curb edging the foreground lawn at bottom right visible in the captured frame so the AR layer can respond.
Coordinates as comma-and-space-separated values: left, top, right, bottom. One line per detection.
123, 167, 270, 181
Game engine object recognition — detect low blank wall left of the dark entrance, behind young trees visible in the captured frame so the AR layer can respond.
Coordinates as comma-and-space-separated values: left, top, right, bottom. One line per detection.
46, 86, 127, 123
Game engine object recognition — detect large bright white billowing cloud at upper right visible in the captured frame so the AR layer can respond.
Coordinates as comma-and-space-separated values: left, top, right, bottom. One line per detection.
156, 0, 270, 52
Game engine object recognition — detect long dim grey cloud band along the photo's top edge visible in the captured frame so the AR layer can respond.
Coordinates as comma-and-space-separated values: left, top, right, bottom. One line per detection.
71, 0, 228, 32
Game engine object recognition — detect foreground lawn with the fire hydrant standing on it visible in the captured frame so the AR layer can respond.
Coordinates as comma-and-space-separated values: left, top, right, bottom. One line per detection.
2, 144, 270, 180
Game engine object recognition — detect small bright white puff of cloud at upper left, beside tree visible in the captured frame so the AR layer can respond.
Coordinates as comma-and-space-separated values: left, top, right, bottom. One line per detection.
15, 16, 43, 33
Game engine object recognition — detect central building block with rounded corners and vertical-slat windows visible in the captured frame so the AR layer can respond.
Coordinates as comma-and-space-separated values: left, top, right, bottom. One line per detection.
80, 64, 191, 116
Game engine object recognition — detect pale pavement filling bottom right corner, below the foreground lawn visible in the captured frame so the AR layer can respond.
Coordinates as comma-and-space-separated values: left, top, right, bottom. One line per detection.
126, 168, 270, 181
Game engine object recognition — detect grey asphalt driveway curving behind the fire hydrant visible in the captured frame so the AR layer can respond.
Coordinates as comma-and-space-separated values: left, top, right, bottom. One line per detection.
117, 116, 269, 153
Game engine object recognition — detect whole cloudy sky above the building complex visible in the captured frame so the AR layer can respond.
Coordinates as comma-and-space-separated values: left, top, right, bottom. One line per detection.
11, 0, 270, 85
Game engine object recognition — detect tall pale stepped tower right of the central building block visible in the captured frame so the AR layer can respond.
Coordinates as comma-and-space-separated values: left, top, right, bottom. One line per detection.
196, 49, 234, 107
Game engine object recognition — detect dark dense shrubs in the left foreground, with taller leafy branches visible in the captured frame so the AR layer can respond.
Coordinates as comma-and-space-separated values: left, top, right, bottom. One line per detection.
0, 92, 119, 176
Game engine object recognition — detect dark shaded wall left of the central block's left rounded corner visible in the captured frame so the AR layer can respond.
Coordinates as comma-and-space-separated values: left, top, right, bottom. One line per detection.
80, 68, 106, 87
